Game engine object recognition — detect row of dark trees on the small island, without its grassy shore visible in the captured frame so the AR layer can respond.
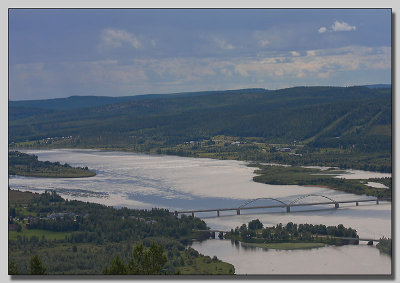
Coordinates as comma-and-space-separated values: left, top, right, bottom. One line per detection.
226, 219, 358, 244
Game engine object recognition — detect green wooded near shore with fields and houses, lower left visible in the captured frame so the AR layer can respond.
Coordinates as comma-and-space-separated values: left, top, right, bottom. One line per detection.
8, 190, 235, 274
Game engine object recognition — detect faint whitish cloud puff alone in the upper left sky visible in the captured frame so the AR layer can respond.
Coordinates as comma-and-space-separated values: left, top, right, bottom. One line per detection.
98, 28, 142, 51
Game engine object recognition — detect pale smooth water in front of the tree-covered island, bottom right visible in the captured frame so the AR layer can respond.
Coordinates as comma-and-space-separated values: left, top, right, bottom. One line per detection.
192, 240, 391, 275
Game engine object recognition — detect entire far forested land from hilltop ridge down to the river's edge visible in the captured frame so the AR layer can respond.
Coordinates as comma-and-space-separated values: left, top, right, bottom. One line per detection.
9, 87, 392, 172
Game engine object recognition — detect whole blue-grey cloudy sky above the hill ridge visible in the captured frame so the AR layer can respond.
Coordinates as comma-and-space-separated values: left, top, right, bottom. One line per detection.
9, 9, 391, 100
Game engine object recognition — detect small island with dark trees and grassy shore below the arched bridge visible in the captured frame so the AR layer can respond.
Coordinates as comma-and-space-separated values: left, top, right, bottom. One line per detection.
225, 219, 359, 250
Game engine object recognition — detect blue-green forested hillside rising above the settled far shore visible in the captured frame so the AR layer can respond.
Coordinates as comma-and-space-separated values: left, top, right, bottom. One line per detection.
9, 87, 392, 171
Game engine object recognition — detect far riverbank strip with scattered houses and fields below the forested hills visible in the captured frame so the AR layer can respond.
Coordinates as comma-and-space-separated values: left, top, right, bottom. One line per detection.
9, 130, 392, 173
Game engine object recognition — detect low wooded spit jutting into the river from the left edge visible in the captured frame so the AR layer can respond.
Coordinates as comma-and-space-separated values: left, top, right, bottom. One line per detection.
8, 151, 96, 178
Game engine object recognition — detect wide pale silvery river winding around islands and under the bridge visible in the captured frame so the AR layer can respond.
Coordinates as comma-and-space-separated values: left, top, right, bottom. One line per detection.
9, 149, 391, 275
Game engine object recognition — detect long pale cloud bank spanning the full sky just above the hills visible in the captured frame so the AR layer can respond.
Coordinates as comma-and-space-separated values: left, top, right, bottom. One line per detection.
10, 46, 391, 100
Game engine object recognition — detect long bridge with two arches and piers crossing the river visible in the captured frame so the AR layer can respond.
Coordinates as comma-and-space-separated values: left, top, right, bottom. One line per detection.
175, 194, 391, 217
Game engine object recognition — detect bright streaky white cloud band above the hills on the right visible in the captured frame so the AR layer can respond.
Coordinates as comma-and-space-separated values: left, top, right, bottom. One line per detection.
234, 46, 391, 78
